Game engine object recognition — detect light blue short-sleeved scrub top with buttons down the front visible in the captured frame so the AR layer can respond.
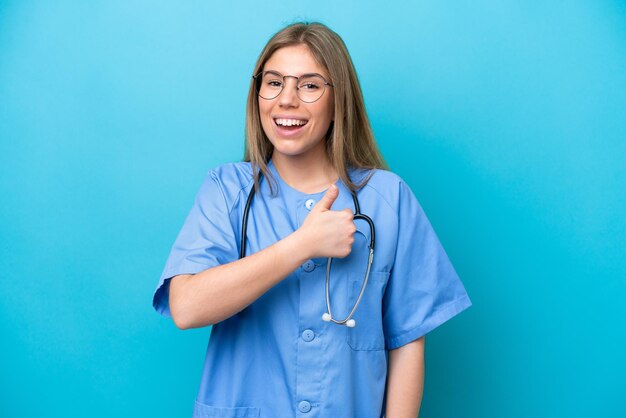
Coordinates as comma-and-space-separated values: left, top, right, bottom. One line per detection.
153, 161, 471, 418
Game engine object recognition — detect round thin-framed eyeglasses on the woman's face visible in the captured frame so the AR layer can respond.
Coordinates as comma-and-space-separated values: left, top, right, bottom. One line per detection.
252, 71, 333, 103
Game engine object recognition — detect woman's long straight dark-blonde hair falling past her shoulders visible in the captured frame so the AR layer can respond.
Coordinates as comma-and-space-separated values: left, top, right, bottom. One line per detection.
244, 22, 387, 193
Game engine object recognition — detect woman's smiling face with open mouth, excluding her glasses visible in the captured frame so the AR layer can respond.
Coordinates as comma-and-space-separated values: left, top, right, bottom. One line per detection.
258, 45, 334, 165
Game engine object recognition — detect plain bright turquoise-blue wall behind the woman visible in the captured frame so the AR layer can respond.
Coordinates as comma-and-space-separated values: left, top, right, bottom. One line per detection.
0, 0, 626, 418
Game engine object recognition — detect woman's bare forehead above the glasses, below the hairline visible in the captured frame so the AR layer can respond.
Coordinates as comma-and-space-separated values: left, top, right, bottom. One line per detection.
263, 45, 328, 77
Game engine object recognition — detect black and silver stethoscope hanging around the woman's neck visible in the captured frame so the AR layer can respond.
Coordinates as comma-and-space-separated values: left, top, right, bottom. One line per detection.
239, 171, 375, 328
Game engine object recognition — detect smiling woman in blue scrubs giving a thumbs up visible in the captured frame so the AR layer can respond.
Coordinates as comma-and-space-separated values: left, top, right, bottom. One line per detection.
154, 23, 471, 418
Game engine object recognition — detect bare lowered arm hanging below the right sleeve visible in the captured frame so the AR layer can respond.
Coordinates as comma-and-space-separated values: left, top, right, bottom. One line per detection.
386, 337, 425, 418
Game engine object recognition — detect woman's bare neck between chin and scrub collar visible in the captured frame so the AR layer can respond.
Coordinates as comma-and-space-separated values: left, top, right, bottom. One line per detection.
272, 150, 338, 194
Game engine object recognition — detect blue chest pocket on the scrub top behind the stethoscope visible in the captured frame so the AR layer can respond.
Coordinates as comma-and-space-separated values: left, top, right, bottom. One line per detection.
346, 270, 389, 351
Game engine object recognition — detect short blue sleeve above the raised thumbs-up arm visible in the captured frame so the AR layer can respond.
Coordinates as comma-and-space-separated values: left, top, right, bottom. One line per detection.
152, 171, 238, 316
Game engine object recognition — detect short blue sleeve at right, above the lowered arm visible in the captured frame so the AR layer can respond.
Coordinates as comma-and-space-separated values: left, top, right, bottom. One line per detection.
383, 181, 472, 350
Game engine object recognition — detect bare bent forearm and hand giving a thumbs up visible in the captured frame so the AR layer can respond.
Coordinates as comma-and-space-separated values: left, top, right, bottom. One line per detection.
169, 186, 356, 329
